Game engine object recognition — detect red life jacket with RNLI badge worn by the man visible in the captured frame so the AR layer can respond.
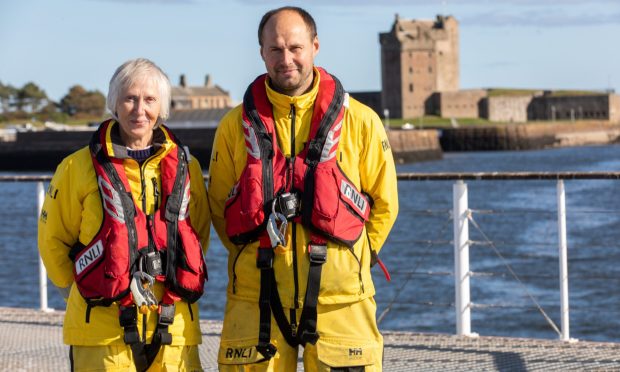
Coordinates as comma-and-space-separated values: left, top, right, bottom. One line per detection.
224, 68, 371, 247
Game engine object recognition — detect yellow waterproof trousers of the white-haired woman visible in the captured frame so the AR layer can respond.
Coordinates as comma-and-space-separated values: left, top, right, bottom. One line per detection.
71, 345, 202, 372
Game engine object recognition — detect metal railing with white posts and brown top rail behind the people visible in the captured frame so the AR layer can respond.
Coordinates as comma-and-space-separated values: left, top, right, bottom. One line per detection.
0, 172, 620, 341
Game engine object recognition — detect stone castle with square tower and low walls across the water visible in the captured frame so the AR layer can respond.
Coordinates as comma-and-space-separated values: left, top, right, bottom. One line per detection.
351, 15, 620, 123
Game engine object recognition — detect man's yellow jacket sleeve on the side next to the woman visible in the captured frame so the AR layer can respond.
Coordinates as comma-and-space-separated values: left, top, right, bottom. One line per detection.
208, 106, 240, 250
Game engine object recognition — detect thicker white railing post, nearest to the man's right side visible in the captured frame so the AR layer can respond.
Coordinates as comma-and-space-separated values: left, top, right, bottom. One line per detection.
452, 180, 472, 336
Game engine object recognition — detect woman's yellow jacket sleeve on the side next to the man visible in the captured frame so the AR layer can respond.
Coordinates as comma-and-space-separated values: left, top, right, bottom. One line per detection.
189, 156, 211, 254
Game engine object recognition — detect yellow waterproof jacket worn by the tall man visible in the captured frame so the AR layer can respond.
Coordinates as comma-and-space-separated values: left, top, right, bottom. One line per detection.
209, 69, 398, 308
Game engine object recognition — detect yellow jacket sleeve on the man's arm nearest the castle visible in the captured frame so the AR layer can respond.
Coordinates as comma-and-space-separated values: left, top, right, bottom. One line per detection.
360, 107, 398, 253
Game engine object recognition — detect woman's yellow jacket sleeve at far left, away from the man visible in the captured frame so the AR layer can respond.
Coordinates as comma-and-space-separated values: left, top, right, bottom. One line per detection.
38, 150, 88, 288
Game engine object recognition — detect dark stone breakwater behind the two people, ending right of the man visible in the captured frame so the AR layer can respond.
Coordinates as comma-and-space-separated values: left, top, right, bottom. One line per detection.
0, 128, 442, 172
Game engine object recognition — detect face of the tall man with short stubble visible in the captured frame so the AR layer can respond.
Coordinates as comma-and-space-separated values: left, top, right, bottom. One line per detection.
260, 11, 319, 96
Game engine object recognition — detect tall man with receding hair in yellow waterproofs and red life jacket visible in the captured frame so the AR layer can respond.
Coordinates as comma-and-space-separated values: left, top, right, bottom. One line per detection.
209, 7, 398, 371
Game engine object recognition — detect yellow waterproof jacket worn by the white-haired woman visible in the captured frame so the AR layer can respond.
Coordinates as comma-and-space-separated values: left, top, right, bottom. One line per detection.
38, 123, 211, 346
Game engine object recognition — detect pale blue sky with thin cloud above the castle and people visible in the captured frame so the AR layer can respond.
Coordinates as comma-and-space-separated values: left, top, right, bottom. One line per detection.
0, 0, 620, 101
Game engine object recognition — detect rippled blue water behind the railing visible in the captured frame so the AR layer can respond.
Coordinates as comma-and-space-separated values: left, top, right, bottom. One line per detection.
0, 146, 620, 342
